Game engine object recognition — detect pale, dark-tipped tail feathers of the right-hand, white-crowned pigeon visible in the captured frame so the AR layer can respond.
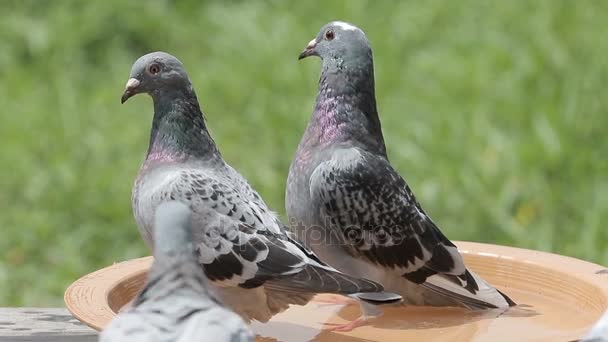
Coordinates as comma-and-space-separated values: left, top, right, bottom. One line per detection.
422, 271, 516, 310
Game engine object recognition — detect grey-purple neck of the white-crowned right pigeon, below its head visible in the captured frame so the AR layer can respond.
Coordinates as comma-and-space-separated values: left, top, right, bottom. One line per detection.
307, 55, 386, 153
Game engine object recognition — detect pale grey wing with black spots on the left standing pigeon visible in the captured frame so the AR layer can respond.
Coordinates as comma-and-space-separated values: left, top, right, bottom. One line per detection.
145, 169, 382, 293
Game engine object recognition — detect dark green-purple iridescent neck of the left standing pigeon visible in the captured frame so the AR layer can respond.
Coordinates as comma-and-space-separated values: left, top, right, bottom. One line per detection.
147, 84, 219, 161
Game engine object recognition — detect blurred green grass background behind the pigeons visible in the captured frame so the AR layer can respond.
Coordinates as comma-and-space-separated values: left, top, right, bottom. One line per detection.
0, 0, 608, 306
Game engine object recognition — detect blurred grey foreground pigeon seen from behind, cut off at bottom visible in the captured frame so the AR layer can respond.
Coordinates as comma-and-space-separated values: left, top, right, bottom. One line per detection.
99, 202, 253, 342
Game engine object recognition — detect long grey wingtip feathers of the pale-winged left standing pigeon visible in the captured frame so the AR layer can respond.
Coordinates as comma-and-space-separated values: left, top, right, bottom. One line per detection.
264, 264, 384, 294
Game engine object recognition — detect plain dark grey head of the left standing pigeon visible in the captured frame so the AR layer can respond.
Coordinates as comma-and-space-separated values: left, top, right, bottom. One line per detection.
120, 51, 190, 103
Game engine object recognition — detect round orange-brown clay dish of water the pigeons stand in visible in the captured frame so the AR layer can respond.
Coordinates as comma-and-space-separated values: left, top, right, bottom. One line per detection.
64, 242, 608, 342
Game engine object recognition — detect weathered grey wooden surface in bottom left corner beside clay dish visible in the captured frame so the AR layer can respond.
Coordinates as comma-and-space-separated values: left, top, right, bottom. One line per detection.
0, 308, 97, 342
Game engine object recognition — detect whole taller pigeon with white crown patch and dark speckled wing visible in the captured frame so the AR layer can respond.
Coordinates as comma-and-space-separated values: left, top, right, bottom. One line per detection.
286, 21, 515, 328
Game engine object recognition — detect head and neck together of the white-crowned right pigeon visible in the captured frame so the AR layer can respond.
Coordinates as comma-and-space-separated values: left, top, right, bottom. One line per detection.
299, 21, 386, 153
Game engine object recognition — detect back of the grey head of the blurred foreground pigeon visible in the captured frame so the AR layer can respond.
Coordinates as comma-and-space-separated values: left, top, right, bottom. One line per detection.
154, 201, 194, 256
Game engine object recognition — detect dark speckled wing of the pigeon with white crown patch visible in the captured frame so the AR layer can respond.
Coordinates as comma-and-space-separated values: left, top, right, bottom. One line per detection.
310, 147, 510, 307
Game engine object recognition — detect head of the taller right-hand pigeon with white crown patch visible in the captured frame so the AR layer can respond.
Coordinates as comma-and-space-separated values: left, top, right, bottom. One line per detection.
298, 21, 371, 64
